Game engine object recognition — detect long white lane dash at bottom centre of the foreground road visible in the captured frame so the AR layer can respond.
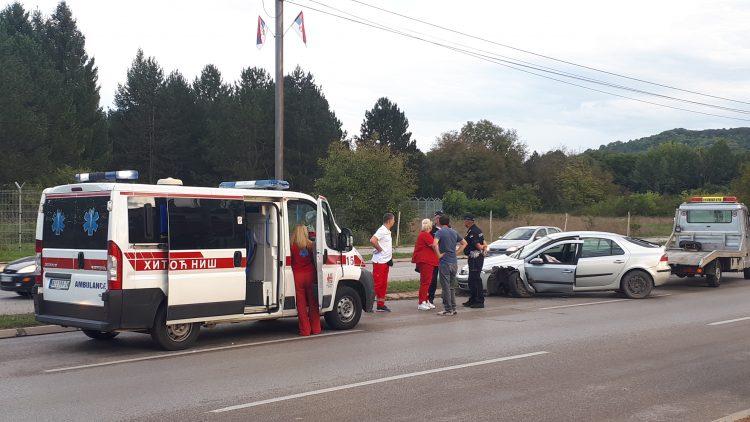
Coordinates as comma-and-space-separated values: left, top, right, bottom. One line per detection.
211, 351, 549, 413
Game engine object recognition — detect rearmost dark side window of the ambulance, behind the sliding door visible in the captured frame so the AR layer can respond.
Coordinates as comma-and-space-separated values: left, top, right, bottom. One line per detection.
128, 196, 167, 243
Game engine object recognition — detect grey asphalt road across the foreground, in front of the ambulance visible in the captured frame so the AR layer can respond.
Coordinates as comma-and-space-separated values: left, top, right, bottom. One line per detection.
0, 276, 750, 421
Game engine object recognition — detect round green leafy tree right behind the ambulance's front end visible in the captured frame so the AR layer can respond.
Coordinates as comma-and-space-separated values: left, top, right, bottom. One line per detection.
315, 143, 416, 230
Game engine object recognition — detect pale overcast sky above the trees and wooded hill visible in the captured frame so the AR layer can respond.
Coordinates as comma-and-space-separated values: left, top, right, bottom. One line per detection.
10, 0, 750, 151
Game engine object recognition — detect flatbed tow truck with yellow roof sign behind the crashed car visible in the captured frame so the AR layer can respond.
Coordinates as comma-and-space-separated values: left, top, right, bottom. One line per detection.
665, 196, 750, 287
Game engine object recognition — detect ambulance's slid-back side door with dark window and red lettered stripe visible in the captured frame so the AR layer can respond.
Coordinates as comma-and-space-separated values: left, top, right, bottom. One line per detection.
167, 196, 246, 323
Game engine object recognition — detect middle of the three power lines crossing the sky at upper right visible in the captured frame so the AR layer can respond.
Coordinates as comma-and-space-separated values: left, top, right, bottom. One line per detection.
307, 0, 750, 114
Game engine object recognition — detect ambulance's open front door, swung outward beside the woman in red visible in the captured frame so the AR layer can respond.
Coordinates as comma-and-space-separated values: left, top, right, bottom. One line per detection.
315, 196, 341, 310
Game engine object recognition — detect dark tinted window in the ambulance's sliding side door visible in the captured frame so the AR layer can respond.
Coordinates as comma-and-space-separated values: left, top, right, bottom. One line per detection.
167, 198, 245, 250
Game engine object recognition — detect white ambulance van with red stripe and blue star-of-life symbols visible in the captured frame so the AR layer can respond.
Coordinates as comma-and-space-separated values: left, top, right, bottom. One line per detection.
34, 171, 374, 350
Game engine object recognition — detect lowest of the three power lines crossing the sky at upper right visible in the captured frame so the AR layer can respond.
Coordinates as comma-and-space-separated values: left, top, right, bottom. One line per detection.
286, 0, 750, 122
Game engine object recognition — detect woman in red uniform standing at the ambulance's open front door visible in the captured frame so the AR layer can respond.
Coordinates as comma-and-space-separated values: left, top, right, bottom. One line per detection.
292, 224, 320, 336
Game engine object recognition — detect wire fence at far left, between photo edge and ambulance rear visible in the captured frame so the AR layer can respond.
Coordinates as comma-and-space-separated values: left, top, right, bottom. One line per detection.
0, 186, 41, 249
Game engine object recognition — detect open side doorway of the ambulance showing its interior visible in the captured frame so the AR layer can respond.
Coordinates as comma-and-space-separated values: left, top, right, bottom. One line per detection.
245, 203, 279, 307
